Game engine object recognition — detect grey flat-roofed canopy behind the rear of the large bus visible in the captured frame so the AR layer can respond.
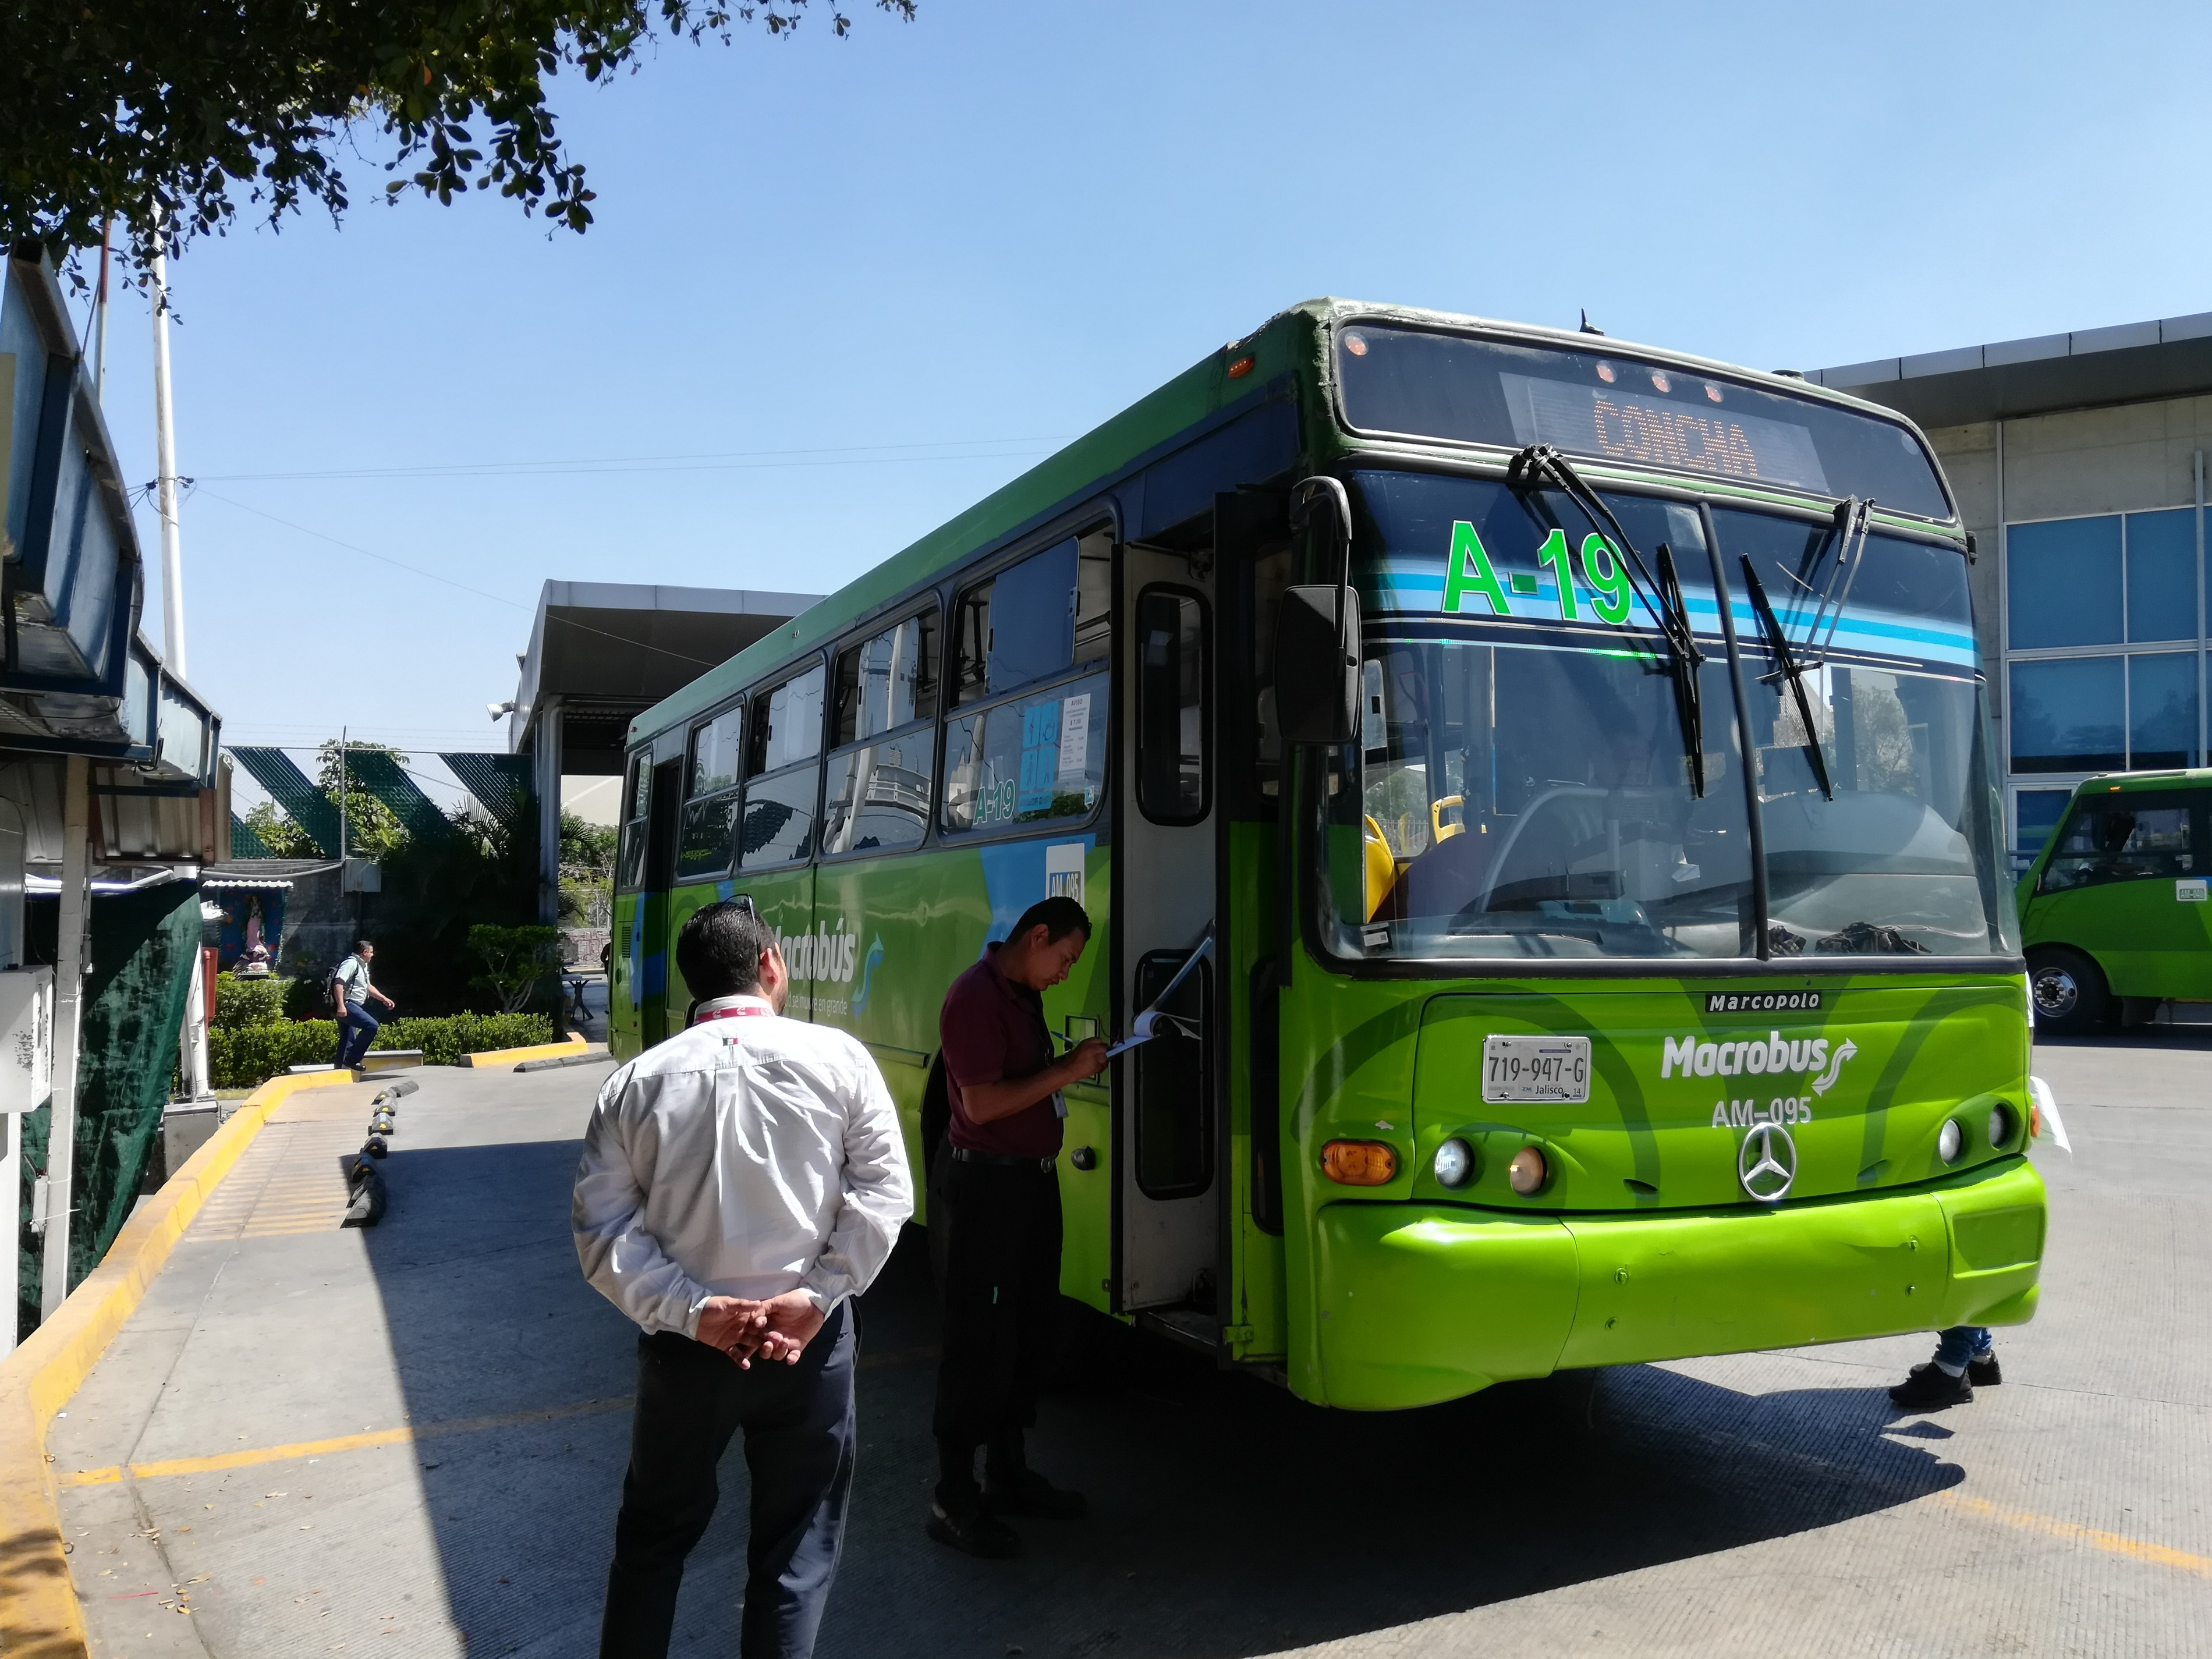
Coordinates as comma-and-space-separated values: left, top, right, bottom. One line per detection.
506, 582, 818, 777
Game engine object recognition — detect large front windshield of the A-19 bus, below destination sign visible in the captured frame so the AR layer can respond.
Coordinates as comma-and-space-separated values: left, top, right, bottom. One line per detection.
1323, 473, 2018, 958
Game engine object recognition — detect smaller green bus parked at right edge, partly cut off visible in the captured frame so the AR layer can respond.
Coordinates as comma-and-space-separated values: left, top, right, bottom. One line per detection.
2019, 768, 2212, 1035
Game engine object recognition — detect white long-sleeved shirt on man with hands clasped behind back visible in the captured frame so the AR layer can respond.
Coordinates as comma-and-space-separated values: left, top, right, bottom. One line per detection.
569, 995, 913, 1336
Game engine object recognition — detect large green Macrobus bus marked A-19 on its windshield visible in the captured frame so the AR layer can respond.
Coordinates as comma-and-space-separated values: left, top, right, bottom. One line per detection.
613, 301, 2044, 1409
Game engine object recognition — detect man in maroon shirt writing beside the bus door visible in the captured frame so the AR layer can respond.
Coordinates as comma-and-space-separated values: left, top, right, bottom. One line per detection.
929, 896, 1106, 1557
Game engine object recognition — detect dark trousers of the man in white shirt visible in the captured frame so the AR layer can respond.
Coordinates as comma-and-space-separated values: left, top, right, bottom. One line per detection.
600, 1303, 856, 1659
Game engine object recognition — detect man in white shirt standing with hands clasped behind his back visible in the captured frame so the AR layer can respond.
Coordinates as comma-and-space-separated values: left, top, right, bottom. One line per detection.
570, 898, 913, 1659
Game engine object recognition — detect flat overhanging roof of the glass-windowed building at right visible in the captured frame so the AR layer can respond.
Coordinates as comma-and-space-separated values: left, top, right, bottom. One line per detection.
1805, 312, 2212, 427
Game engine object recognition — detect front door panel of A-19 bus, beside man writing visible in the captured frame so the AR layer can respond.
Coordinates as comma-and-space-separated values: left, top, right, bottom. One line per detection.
1112, 547, 1223, 1341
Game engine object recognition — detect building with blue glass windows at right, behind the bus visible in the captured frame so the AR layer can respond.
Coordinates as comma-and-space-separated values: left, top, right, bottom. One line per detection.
1805, 325, 2212, 871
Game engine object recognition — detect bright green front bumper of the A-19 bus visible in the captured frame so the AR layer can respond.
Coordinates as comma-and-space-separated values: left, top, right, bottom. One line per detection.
1314, 1157, 2044, 1411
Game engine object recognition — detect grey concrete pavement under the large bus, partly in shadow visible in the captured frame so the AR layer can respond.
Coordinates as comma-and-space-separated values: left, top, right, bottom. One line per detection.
49, 1031, 2212, 1659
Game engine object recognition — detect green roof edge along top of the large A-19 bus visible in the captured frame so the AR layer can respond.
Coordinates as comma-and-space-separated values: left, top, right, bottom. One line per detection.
628, 299, 1947, 746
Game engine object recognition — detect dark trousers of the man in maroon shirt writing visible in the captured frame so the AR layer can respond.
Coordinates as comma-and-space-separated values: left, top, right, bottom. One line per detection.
929, 1146, 1059, 1511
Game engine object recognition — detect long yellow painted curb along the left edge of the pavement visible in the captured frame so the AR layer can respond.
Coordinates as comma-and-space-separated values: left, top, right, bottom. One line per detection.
0, 1070, 354, 1659
